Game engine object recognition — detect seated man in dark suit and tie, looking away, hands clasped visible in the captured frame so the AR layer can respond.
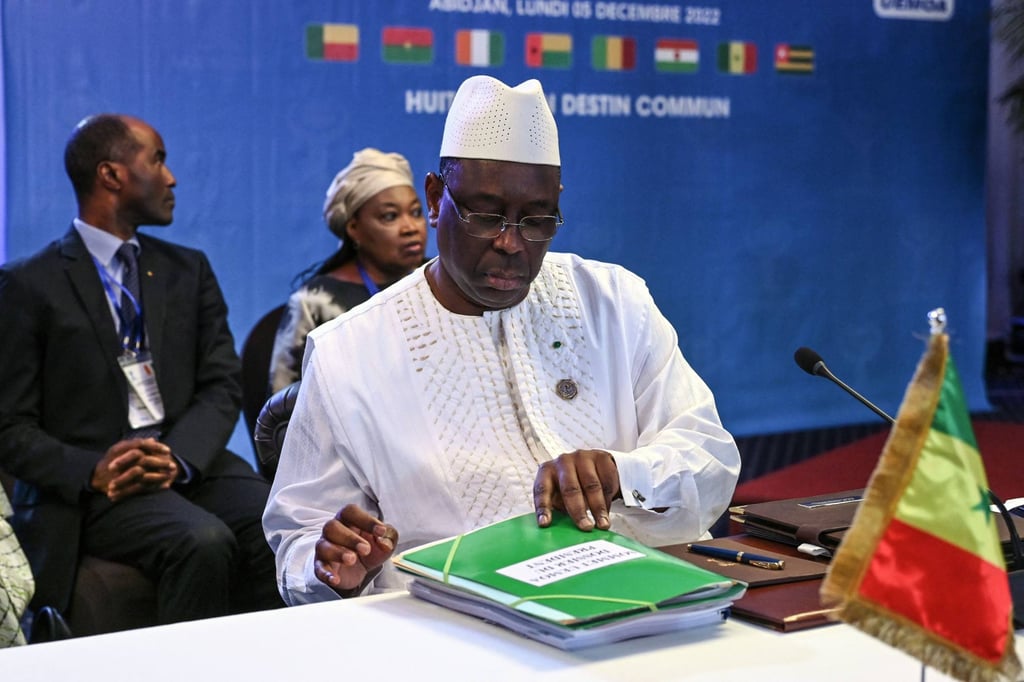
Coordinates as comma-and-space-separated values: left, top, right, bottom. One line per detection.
0, 115, 282, 623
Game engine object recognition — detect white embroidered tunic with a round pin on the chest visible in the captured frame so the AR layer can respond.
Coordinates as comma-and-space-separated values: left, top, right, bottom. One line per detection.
264, 253, 739, 603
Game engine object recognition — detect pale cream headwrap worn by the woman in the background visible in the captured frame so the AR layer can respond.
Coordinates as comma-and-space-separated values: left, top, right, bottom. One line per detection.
324, 146, 415, 239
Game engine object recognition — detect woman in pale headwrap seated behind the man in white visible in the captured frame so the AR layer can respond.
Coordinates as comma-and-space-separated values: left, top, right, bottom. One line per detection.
270, 147, 427, 392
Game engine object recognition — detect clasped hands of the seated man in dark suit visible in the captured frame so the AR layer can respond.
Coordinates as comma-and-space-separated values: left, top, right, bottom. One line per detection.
89, 438, 178, 502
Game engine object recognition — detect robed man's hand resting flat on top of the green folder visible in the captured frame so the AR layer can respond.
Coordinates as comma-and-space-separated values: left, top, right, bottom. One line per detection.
534, 450, 621, 530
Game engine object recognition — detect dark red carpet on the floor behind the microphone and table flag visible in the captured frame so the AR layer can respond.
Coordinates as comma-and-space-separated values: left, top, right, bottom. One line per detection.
732, 421, 1024, 505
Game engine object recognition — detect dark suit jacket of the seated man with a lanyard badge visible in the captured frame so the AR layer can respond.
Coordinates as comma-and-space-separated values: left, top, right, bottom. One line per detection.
0, 227, 255, 609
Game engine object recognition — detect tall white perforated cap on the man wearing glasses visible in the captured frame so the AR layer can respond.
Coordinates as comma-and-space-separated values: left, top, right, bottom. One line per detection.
440, 76, 561, 166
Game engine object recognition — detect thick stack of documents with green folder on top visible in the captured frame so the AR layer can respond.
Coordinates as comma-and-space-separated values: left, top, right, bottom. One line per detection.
394, 514, 746, 649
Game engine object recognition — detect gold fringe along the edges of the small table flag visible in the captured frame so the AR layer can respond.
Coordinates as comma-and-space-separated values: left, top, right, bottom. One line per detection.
820, 334, 1021, 682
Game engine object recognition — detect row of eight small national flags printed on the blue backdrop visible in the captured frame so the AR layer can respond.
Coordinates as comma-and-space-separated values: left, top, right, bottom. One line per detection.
306, 24, 814, 76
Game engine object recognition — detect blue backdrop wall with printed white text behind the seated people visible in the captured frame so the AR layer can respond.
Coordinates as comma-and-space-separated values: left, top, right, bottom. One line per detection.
2, 0, 988, 456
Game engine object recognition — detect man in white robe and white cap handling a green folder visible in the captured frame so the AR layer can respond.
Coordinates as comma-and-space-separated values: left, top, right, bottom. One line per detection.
263, 76, 739, 604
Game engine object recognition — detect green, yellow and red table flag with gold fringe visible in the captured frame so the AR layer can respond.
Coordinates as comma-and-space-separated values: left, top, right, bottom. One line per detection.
821, 308, 1021, 682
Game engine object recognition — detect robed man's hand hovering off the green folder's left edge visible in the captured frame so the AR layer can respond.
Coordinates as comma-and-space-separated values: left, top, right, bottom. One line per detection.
313, 505, 398, 597
